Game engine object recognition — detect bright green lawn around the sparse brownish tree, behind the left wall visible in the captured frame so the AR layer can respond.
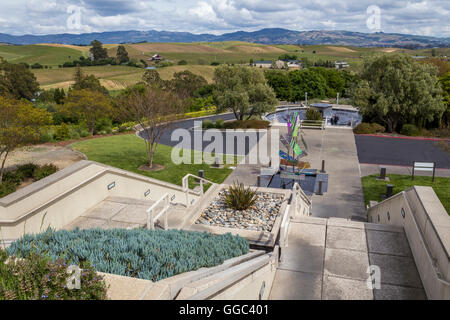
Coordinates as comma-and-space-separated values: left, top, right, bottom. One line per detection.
71, 134, 237, 185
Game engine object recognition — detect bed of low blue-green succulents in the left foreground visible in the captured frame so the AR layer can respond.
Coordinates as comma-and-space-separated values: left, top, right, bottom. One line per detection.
8, 229, 249, 281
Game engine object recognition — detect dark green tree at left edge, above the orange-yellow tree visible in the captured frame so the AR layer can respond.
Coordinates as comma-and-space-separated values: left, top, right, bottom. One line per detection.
0, 57, 39, 100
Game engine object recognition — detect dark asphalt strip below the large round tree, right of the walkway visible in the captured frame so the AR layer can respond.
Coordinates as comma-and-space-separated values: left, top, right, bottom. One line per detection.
355, 135, 450, 169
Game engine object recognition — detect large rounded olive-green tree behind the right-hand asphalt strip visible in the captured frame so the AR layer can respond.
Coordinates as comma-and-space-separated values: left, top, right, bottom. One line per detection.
352, 54, 445, 132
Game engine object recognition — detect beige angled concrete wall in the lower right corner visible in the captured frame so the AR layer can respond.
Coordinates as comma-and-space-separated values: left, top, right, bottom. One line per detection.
367, 186, 450, 299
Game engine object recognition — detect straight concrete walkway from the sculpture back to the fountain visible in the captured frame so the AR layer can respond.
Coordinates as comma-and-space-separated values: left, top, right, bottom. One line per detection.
302, 128, 366, 219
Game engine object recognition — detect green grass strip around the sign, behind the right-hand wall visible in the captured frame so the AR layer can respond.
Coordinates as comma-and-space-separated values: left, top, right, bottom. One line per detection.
362, 174, 450, 214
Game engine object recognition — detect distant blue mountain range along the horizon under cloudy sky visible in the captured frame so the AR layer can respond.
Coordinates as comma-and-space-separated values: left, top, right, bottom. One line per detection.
0, 28, 450, 49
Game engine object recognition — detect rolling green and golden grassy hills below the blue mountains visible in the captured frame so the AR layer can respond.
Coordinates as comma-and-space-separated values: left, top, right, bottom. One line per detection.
0, 41, 450, 90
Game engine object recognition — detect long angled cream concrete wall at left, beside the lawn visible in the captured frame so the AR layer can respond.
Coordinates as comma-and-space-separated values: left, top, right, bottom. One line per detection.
0, 161, 198, 245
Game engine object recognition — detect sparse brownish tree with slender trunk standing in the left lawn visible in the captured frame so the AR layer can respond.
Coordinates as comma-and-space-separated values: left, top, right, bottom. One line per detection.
120, 87, 184, 168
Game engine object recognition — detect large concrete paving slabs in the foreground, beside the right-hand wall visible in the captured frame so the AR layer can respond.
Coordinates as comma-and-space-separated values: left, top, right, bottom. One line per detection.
270, 217, 426, 300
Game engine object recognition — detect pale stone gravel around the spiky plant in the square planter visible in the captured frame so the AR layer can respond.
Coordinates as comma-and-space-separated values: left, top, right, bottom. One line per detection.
195, 189, 284, 232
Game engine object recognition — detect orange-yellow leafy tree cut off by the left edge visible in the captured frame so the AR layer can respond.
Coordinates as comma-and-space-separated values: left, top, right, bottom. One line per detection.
0, 96, 52, 184
